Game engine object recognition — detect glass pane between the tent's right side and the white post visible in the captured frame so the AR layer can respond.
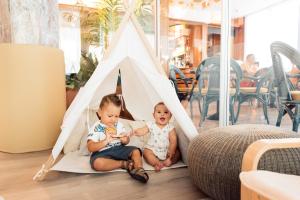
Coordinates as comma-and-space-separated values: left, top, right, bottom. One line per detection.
160, 0, 221, 130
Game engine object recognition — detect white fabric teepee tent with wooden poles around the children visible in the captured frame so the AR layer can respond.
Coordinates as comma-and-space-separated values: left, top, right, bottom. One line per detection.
34, 0, 197, 180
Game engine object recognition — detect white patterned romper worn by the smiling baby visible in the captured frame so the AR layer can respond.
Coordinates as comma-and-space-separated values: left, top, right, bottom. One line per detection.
144, 122, 174, 160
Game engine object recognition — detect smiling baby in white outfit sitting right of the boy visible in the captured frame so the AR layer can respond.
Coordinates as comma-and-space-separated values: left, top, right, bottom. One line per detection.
133, 102, 180, 171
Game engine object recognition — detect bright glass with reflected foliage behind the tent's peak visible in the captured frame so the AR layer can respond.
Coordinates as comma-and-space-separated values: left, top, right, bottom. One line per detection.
59, 0, 155, 74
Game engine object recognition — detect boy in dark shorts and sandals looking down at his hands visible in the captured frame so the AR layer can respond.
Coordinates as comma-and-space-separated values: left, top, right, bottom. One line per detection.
87, 94, 149, 183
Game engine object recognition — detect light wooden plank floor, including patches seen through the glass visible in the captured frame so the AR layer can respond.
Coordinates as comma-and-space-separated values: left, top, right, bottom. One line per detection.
0, 103, 291, 200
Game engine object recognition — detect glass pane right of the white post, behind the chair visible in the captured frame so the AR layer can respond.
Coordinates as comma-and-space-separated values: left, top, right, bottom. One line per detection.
231, 0, 300, 130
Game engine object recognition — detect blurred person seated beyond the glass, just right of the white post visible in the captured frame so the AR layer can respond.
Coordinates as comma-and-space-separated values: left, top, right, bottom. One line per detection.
240, 54, 259, 87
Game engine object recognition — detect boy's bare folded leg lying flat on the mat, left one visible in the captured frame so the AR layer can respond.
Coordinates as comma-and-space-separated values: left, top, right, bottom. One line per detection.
93, 158, 123, 171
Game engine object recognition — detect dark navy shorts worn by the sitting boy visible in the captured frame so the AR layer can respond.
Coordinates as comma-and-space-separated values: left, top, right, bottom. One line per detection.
90, 145, 142, 169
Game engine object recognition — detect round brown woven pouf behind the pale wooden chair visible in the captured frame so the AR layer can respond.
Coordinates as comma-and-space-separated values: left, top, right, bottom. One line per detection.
188, 124, 300, 200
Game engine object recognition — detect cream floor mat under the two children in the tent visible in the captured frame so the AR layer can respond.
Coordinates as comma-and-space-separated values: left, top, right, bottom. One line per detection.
51, 151, 187, 173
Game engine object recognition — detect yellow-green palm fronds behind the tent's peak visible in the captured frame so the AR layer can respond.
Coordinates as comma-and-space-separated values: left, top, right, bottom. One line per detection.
81, 0, 154, 49
